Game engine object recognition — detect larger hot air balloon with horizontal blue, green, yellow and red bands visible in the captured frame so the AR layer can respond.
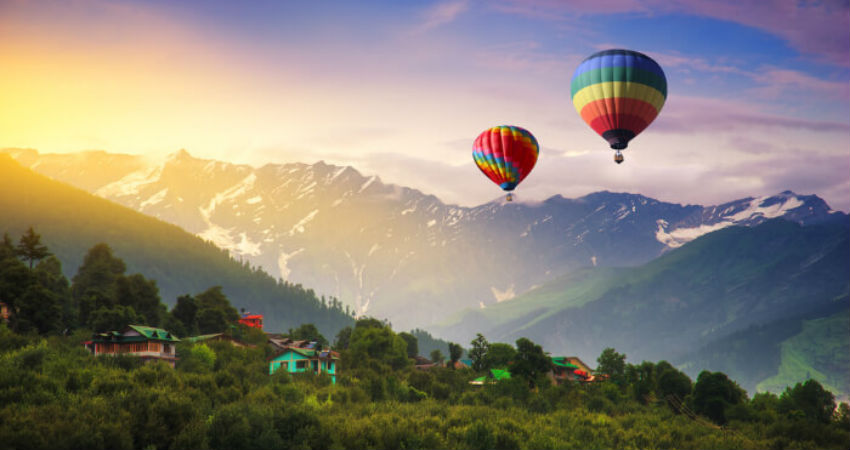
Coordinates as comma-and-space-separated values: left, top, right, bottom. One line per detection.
571, 49, 667, 164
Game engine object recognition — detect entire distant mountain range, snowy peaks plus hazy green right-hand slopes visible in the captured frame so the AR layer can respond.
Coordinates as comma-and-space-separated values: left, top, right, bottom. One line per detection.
5, 149, 850, 393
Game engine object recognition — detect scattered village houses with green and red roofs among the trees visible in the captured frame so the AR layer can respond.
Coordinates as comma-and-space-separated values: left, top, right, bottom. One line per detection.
83, 313, 602, 386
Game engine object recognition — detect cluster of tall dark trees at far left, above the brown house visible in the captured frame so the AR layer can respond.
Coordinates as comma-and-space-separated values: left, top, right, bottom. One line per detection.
0, 227, 252, 336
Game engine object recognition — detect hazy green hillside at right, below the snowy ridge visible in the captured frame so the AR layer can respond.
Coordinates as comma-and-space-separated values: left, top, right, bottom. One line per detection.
434, 219, 850, 395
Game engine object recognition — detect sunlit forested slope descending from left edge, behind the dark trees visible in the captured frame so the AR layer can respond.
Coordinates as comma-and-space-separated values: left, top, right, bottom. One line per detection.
0, 154, 352, 336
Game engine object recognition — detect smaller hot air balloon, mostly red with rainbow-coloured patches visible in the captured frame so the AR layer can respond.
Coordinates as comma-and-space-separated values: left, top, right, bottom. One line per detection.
472, 125, 540, 201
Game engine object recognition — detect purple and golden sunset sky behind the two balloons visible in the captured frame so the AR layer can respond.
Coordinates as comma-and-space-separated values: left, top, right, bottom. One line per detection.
0, 0, 850, 211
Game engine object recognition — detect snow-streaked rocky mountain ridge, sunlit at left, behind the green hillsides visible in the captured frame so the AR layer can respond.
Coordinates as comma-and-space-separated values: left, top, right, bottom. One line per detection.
7, 150, 844, 329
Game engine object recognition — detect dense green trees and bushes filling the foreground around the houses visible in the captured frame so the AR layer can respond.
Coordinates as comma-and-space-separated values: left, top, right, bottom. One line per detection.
0, 229, 850, 449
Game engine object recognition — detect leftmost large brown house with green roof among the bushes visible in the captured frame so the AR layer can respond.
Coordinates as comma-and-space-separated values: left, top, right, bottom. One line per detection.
84, 325, 180, 367
